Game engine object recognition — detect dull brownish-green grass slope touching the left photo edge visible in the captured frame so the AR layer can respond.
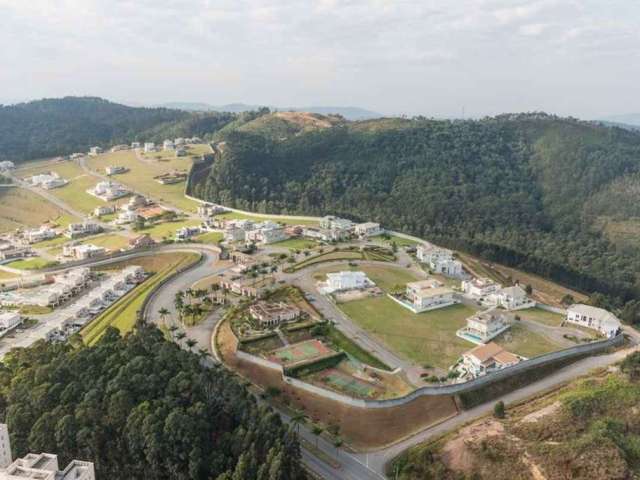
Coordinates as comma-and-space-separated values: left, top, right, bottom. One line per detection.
0, 187, 73, 233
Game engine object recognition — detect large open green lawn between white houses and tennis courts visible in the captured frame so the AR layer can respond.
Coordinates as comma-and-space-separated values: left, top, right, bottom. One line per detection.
339, 296, 475, 369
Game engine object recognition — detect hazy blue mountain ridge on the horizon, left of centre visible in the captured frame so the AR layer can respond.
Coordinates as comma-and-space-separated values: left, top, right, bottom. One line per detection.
153, 102, 383, 120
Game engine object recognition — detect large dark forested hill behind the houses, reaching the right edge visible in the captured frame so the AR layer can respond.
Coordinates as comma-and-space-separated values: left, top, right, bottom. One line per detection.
194, 114, 640, 312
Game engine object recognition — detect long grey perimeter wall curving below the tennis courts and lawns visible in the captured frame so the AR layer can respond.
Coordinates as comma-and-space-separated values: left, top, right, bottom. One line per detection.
236, 334, 624, 408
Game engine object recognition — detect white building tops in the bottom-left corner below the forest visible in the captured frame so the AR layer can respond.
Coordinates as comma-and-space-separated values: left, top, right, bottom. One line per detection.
0, 423, 96, 480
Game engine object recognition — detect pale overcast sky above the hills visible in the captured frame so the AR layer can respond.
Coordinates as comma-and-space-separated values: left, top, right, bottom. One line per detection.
0, 0, 640, 118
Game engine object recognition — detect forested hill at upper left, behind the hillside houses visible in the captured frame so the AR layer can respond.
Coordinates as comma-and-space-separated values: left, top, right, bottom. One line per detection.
0, 97, 235, 161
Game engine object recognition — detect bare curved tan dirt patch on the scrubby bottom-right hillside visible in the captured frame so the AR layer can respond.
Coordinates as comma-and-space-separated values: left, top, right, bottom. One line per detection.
442, 419, 504, 474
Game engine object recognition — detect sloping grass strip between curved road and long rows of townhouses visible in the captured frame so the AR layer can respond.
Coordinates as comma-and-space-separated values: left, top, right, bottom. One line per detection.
80, 253, 199, 345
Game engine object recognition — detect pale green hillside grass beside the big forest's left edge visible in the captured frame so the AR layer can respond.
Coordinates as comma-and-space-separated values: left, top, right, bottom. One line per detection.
87, 150, 198, 212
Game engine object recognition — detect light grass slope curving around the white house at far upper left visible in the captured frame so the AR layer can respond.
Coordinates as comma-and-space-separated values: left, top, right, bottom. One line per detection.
16, 160, 106, 214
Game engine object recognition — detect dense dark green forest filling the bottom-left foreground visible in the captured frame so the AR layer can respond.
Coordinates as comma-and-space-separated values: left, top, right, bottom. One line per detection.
0, 325, 306, 480
